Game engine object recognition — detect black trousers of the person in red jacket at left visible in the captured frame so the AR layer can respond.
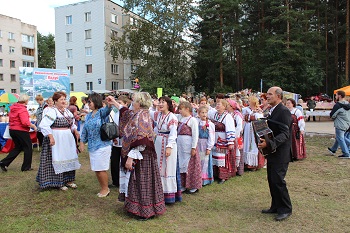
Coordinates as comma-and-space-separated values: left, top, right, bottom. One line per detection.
1, 129, 32, 171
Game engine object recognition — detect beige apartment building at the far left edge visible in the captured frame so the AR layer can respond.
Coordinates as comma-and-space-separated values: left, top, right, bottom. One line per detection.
0, 14, 38, 93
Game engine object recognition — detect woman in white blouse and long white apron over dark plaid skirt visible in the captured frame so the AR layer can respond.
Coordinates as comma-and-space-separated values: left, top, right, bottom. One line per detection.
36, 91, 80, 191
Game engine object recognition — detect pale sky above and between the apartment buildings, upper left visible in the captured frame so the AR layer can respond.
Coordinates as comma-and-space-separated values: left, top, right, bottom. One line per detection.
0, 0, 123, 35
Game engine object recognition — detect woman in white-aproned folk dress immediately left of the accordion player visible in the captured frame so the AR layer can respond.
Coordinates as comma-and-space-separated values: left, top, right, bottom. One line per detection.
242, 96, 265, 170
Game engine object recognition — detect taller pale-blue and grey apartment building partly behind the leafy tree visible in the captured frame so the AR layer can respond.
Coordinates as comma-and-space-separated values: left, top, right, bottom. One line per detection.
55, 0, 137, 92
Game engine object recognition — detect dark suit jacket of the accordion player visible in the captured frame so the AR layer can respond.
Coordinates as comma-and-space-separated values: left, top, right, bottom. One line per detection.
266, 103, 292, 163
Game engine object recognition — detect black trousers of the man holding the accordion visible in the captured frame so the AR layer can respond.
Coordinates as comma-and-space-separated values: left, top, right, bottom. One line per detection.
267, 163, 292, 214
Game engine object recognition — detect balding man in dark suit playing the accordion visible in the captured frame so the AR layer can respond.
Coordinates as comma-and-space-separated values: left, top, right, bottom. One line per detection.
258, 87, 292, 221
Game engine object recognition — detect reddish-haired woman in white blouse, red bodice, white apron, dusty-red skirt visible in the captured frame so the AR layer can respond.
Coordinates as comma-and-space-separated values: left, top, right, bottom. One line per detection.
177, 101, 202, 194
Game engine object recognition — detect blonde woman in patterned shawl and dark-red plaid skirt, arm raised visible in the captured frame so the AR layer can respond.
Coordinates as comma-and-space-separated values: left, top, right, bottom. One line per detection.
106, 92, 165, 220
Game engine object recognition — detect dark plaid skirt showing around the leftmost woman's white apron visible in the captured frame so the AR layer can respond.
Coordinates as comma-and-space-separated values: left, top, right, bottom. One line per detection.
36, 136, 75, 189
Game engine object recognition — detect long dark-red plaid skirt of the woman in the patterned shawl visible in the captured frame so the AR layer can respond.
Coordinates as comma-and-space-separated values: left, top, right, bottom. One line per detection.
125, 148, 165, 218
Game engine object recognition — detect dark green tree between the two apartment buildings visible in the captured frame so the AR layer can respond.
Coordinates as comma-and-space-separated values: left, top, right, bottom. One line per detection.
37, 32, 56, 69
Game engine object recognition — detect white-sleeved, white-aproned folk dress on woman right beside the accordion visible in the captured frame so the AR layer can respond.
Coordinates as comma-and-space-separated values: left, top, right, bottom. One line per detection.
242, 107, 264, 168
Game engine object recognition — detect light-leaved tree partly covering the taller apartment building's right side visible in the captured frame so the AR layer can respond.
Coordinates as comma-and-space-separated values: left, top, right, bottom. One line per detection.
106, 0, 193, 94
